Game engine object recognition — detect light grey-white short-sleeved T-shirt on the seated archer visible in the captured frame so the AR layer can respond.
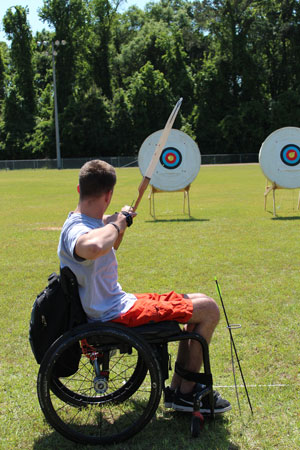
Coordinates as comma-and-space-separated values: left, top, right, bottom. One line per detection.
57, 212, 136, 322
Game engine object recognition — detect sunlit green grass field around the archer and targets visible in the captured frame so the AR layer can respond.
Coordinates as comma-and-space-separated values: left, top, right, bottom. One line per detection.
0, 165, 300, 450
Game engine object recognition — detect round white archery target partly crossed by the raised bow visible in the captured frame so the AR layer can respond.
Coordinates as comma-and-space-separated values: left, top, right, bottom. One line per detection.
138, 129, 201, 191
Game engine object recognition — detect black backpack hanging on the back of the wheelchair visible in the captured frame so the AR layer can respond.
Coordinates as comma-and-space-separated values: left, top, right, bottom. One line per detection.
29, 267, 86, 377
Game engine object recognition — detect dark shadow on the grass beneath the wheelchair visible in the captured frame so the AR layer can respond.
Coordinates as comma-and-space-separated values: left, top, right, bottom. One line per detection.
32, 411, 240, 450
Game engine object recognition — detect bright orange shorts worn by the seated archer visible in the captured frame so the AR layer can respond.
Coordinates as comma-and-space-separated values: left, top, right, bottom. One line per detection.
112, 291, 193, 327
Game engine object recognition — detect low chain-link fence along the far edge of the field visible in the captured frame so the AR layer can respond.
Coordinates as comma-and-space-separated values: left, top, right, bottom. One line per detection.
0, 153, 258, 170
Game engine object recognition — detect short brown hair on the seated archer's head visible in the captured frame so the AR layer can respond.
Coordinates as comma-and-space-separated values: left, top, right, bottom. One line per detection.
79, 159, 117, 200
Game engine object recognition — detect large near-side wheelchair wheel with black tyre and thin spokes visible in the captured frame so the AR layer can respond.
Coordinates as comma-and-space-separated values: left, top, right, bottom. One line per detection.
37, 324, 162, 445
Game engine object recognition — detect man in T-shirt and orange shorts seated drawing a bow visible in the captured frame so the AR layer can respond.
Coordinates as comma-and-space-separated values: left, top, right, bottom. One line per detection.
58, 160, 231, 414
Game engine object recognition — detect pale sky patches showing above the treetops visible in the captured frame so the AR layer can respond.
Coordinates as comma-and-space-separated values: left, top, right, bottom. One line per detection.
0, 0, 150, 44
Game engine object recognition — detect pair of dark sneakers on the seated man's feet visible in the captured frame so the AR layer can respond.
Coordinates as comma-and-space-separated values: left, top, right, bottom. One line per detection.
173, 385, 231, 414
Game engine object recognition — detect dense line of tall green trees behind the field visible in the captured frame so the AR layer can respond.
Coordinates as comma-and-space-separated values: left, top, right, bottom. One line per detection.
0, 0, 300, 159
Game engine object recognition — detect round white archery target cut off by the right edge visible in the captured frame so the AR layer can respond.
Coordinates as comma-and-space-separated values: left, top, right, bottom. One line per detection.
259, 127, 300, 189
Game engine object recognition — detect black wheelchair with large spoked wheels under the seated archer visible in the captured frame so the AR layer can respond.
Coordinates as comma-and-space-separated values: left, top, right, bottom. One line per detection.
37, 269, 214, 445
